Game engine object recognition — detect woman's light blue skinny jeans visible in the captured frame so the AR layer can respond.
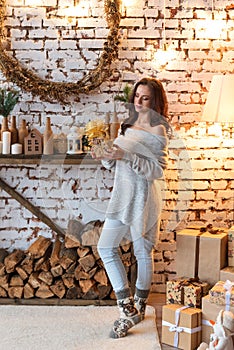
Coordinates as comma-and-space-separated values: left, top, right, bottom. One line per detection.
98, 219, 153, 293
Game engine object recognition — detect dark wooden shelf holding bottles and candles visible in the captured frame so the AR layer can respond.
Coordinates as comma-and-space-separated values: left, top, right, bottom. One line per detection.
0, 153, 100, 164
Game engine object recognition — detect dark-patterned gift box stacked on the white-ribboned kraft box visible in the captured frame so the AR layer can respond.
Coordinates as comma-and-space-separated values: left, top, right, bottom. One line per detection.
166, 277, 210, 308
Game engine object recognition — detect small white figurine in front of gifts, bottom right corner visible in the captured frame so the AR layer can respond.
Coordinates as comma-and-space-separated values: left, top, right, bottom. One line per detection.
197, 310, 234, 350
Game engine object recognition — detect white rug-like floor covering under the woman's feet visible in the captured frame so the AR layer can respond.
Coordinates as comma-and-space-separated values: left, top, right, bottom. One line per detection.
0, 305, 161, 350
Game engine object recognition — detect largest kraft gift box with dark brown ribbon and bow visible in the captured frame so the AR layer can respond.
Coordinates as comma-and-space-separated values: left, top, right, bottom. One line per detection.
176, 227, 228, 285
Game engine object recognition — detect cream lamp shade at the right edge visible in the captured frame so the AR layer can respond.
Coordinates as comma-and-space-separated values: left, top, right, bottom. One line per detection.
202, 74, 234, 123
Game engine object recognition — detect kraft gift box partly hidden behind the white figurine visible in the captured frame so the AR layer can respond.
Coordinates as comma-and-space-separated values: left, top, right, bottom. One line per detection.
202, 295, 234, 344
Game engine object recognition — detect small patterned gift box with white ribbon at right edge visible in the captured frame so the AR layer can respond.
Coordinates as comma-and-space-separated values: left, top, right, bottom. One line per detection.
209, 281, 234, 306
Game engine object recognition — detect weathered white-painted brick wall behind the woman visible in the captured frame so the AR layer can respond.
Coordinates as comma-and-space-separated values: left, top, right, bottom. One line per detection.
0, 0, 234, 291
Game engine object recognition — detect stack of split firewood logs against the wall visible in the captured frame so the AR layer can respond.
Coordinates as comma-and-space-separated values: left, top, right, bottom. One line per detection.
0, 220, 135, 300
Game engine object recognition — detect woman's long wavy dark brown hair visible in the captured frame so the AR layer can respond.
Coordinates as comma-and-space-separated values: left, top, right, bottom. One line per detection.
121, 78, 171, 135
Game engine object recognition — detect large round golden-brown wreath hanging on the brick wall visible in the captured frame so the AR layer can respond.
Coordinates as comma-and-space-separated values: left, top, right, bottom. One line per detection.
0, 0, 120, 103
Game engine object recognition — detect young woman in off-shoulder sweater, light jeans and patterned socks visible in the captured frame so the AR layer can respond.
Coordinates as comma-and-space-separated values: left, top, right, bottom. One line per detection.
93, 78, 171, 338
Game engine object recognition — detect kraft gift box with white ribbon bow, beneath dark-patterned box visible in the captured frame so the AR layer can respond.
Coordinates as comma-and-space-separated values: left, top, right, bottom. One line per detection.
162, 304, 202, 350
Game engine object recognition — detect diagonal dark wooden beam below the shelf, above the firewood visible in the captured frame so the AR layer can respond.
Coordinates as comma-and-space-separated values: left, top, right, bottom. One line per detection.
0, 178, 65, 237
